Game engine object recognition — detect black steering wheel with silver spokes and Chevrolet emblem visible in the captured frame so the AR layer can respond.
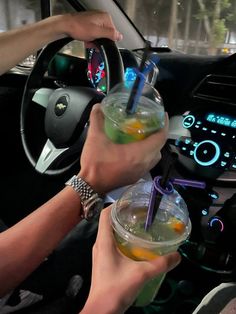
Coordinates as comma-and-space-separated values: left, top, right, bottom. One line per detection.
20, 38, 124, 175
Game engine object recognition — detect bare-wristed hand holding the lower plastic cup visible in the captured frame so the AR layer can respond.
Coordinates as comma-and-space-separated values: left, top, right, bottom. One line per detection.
82, 206, 180, 314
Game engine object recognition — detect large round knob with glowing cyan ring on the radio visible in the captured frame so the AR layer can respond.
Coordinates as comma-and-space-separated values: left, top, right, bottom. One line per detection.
193, 140, 220, 167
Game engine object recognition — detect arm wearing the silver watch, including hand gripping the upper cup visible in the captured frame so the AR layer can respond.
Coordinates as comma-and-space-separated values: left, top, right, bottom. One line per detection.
0, 105, 168, 296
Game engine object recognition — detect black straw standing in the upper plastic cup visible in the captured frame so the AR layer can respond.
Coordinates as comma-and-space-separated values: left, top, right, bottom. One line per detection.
126, 41, 151, 114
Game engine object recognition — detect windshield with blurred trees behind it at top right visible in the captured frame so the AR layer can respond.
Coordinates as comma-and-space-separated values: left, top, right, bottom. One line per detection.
117, 0, 236, 55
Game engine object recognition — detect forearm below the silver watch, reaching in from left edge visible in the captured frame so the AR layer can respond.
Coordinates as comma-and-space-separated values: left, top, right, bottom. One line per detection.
0, 187, 81, 296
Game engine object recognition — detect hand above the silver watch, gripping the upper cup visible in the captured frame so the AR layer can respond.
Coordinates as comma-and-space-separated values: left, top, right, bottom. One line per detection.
79, 104, 168, 193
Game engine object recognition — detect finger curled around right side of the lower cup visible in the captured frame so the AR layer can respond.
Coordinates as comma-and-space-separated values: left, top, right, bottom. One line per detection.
150, 252, 181, 276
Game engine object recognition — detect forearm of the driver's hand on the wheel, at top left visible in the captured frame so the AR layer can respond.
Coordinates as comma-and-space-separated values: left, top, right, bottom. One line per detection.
0, 15, 69, 74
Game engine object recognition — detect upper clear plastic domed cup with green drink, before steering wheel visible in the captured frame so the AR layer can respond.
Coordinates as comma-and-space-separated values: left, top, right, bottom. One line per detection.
102, 81, 165, 144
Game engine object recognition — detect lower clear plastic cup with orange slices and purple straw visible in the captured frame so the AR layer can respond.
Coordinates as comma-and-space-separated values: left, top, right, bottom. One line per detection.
111, 181, 191, 306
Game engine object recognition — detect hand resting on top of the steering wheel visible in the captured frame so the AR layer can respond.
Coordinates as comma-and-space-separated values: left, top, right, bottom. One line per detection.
60, 11, 122, 42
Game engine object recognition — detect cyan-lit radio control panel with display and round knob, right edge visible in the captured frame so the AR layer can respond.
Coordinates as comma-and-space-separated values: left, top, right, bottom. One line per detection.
169, 108, 236, 180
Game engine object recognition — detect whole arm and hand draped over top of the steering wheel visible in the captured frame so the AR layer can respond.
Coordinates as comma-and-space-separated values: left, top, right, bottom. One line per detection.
0, 11, 122, 74
